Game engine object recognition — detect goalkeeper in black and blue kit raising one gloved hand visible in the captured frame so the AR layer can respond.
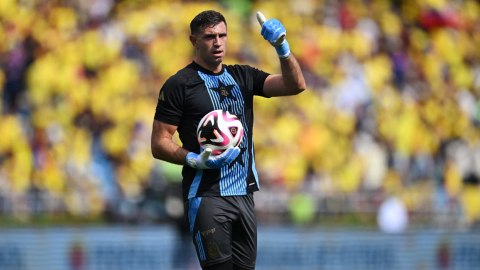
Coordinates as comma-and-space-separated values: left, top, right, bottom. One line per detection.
151, 10, 306, 270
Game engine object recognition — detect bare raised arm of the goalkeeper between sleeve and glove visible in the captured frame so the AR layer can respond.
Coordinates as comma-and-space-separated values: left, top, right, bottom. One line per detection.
263, 54, 306, 97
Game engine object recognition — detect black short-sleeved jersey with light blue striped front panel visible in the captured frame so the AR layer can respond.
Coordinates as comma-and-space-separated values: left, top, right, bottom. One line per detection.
155, 62, 269, 200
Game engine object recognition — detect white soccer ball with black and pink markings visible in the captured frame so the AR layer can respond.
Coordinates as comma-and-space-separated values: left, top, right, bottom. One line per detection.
197, 110, 243, 155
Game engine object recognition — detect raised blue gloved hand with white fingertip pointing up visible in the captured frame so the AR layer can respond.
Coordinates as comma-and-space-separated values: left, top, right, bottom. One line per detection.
257, 11, 290, 59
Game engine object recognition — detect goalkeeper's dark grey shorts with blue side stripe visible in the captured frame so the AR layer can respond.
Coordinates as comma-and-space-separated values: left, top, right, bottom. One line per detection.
185, 193, 257, 269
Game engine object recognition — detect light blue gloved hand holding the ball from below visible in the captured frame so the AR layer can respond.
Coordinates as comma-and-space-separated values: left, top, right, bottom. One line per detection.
186, 147, 240, 169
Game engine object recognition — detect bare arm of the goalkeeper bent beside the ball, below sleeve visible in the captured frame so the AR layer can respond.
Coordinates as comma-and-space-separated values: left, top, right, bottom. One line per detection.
151, 120, 188, 165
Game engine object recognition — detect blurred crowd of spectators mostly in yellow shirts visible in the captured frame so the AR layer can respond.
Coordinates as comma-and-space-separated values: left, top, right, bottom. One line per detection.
0, 0, 480, 229
